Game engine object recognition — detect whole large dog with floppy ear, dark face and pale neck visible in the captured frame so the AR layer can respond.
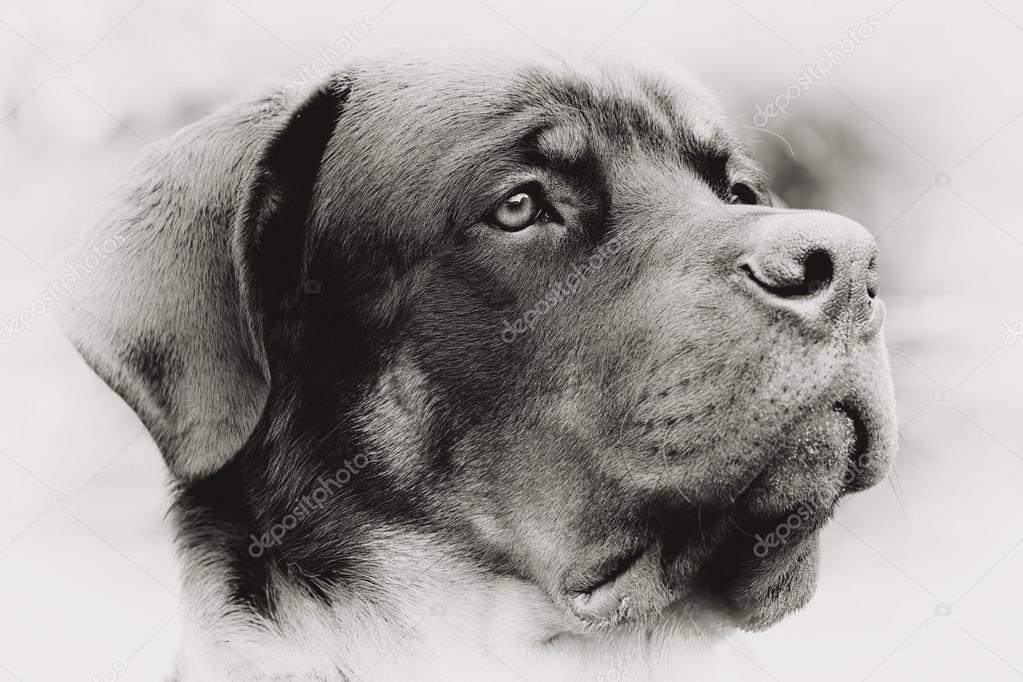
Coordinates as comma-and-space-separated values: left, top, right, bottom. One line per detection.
62, 56, 896, 682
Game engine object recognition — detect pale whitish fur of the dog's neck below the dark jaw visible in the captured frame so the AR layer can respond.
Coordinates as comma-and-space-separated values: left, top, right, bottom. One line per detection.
171, 515, 740, 682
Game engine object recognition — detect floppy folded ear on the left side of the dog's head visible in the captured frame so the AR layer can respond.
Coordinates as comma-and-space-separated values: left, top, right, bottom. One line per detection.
61, 79, 349, 479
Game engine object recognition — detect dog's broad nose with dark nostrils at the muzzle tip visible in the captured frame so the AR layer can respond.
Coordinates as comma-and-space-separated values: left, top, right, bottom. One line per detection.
740, 211, 880, 332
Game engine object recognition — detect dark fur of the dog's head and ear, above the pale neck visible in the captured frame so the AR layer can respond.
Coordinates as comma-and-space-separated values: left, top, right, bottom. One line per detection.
58, 54, 893, 678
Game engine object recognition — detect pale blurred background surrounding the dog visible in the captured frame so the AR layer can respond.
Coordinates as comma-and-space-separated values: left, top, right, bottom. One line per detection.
0, 0, 1023, 682
